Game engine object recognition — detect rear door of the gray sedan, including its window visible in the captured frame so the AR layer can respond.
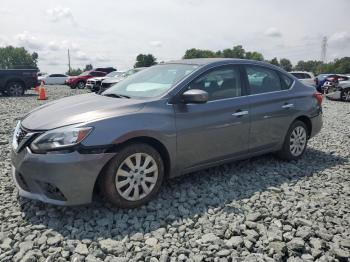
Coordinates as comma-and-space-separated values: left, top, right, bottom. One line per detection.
245, 65, 295, 152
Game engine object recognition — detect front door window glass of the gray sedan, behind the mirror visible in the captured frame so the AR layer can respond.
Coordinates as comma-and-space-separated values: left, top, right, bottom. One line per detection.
188, 67, 242, 101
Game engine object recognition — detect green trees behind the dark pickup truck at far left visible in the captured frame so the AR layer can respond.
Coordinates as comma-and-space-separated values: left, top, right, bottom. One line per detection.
0, 46, 39, 69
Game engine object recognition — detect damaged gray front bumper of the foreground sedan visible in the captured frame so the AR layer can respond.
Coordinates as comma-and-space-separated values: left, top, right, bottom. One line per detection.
11, 147, 114, 206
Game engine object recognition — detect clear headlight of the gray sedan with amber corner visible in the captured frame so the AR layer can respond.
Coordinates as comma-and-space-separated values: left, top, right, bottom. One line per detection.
30, 126, 92, 153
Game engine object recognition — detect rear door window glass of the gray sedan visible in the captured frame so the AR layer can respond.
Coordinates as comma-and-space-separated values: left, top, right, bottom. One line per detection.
245, 66, 284, 95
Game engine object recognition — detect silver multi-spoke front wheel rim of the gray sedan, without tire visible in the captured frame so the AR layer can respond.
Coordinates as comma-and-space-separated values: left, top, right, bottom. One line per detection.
115, 153, 158, 201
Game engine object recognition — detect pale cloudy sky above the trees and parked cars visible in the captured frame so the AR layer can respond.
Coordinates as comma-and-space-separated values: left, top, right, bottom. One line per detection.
0, 0, 350, 73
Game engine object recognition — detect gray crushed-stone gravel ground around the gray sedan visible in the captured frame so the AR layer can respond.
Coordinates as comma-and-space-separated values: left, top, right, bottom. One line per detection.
0, 86, 350, 262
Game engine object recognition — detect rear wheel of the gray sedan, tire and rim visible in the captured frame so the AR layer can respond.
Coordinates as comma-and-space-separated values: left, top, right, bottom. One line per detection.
277, 120, 308, 161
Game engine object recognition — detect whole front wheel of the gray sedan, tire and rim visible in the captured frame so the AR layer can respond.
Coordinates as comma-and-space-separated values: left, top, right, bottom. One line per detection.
100, 143, 164, 208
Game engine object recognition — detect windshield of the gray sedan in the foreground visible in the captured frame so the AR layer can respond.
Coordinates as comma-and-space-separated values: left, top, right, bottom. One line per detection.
103, 64, 198, 97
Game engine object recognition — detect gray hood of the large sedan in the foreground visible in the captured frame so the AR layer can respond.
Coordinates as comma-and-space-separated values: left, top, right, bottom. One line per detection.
22, 94, 144, 130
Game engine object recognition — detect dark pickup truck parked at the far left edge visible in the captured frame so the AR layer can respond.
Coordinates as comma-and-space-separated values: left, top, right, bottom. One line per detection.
0, 69, 38, 96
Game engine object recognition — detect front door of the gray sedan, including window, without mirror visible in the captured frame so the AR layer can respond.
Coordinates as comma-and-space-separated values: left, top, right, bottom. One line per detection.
174, 66, 249, 169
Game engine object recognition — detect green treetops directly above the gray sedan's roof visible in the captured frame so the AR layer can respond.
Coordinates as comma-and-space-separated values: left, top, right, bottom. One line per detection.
183, 45, 264, 61
